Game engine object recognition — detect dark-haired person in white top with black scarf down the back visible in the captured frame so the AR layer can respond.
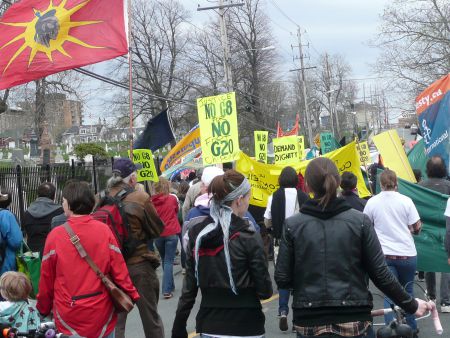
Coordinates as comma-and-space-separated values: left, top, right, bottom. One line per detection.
264, 167, 309, 331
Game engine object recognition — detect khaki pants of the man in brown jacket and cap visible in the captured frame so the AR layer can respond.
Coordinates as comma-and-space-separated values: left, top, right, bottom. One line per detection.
116, 261, 164, 338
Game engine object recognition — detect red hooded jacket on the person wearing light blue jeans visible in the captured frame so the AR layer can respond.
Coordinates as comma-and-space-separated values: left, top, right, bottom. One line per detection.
151, 194, 181, 237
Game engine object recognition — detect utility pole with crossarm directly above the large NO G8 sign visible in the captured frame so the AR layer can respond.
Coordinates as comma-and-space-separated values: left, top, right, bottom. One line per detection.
197, 0, 244, 92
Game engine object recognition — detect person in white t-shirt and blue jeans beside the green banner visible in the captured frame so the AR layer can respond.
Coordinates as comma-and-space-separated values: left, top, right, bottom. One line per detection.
364, 169, 422, 331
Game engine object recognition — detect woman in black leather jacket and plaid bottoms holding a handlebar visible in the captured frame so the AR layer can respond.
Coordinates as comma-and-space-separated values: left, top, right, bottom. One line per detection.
275, 158, 431, 337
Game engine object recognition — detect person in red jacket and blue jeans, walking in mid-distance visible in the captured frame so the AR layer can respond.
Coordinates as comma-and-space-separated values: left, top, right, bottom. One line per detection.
151, 177, 181, 299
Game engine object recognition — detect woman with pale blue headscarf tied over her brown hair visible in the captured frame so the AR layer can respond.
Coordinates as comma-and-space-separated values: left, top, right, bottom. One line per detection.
172, 170, 273, 338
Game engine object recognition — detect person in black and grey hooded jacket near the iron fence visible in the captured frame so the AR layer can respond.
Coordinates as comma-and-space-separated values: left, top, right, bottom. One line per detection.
22, 182, 64, 257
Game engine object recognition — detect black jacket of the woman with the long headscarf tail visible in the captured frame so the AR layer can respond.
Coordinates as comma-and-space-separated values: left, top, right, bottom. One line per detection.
172, 215, 273, 338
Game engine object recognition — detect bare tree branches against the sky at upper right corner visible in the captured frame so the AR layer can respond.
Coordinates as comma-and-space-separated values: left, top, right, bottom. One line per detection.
372, 0, 450, 103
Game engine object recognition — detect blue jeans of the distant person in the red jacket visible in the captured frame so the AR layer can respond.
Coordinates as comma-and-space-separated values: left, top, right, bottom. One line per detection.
155, 235, 178, 294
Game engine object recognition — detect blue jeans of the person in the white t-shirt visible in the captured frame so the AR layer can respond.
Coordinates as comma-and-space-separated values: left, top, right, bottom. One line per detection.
384, 257, 417, 330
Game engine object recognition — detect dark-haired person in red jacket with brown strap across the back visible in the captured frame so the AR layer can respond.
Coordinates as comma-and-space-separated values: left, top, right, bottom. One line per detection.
36, 182, 139, 338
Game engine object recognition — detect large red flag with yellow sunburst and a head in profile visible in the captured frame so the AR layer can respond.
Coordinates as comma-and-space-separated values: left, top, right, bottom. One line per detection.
0, 0, 128, 89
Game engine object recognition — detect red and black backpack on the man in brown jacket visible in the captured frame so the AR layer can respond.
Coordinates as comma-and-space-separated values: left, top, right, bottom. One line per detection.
92, 189, 147, 259
